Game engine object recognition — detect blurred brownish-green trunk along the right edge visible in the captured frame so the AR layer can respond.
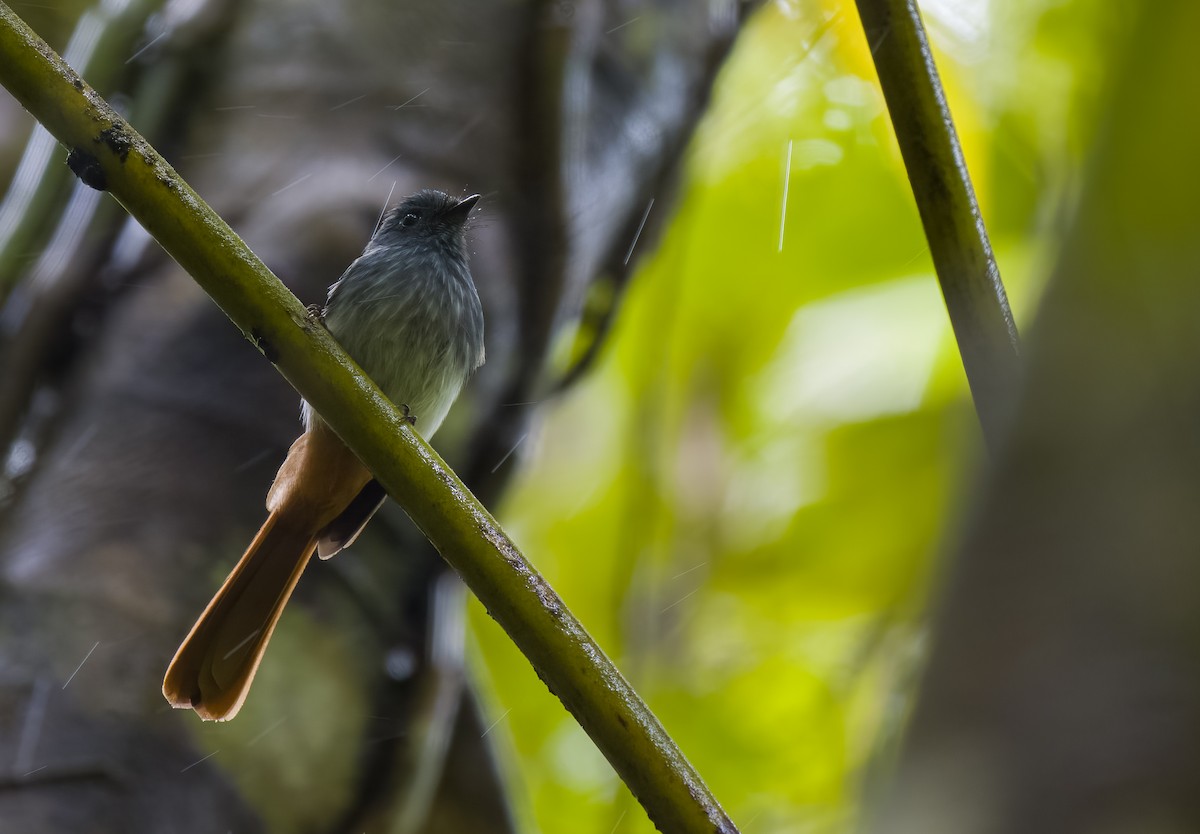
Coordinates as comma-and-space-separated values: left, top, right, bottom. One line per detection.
870, 0, 1200, 834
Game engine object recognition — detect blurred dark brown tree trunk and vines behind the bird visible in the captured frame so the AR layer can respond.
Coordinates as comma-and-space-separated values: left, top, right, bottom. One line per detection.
0, 0, 743, 834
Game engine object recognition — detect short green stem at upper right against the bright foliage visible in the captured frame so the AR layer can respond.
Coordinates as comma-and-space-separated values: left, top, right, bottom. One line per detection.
857, 0, 1020, 449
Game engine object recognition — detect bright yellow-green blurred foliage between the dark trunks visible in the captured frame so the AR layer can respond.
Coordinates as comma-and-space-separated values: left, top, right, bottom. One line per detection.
472, 0, 1113, 834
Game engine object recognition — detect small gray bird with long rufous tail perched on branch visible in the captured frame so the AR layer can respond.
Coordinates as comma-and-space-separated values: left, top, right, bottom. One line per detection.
162, 190, 484, 721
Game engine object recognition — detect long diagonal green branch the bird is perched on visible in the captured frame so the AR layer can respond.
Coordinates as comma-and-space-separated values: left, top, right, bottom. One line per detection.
0, 4, 737, 834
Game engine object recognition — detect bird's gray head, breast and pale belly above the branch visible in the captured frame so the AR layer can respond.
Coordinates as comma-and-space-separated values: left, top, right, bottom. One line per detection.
302, 190, 484, 439
